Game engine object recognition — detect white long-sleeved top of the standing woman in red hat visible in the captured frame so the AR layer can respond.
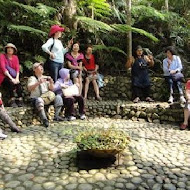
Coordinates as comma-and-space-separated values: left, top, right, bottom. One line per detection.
42, 38, 69, 64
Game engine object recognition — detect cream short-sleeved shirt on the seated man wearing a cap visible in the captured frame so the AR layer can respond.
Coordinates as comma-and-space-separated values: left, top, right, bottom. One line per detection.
27, 76, 49, 98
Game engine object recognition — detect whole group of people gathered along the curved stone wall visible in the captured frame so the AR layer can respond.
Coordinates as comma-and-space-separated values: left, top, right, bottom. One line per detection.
0, 25, 190, 138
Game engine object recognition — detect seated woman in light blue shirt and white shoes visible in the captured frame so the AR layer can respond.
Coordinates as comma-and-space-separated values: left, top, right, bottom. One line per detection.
163, 47, 186, 104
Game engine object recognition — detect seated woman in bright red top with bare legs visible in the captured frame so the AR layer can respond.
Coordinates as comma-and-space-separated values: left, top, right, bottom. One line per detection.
83, 45, 101, 100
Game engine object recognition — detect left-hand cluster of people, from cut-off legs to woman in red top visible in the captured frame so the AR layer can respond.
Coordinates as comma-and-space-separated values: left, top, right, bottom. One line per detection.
0, 25, 101, 138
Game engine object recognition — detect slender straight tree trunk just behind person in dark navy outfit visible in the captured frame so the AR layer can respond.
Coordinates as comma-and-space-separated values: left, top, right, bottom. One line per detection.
126, 0, 132, 58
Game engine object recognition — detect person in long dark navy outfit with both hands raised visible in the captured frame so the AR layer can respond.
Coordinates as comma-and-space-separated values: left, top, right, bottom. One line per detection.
126, 45, 154, 103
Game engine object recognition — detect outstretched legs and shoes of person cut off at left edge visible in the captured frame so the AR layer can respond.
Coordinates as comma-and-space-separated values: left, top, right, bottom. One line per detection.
0, 92, 21, 138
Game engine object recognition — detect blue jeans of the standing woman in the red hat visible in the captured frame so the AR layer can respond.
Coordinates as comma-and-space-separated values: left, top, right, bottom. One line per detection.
49, 60, 62, 82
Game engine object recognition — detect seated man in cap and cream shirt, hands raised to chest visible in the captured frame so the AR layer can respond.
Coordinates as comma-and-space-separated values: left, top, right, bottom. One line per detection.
28, 63, 64, 127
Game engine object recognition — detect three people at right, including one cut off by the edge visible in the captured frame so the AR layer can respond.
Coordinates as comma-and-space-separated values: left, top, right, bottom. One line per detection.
126, 46, 190, 130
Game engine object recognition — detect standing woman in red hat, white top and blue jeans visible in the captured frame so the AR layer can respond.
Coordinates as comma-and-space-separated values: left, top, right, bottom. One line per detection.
42, 25, 73, 82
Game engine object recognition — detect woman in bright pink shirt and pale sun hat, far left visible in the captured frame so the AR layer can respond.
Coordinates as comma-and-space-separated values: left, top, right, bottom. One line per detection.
0, 43, 23, 107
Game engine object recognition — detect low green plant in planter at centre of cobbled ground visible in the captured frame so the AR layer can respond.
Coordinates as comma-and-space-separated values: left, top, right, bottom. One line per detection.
75, 128, 130, 153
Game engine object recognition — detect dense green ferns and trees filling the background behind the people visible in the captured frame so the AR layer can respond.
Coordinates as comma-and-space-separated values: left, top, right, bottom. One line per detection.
0, 0, 190, 74
